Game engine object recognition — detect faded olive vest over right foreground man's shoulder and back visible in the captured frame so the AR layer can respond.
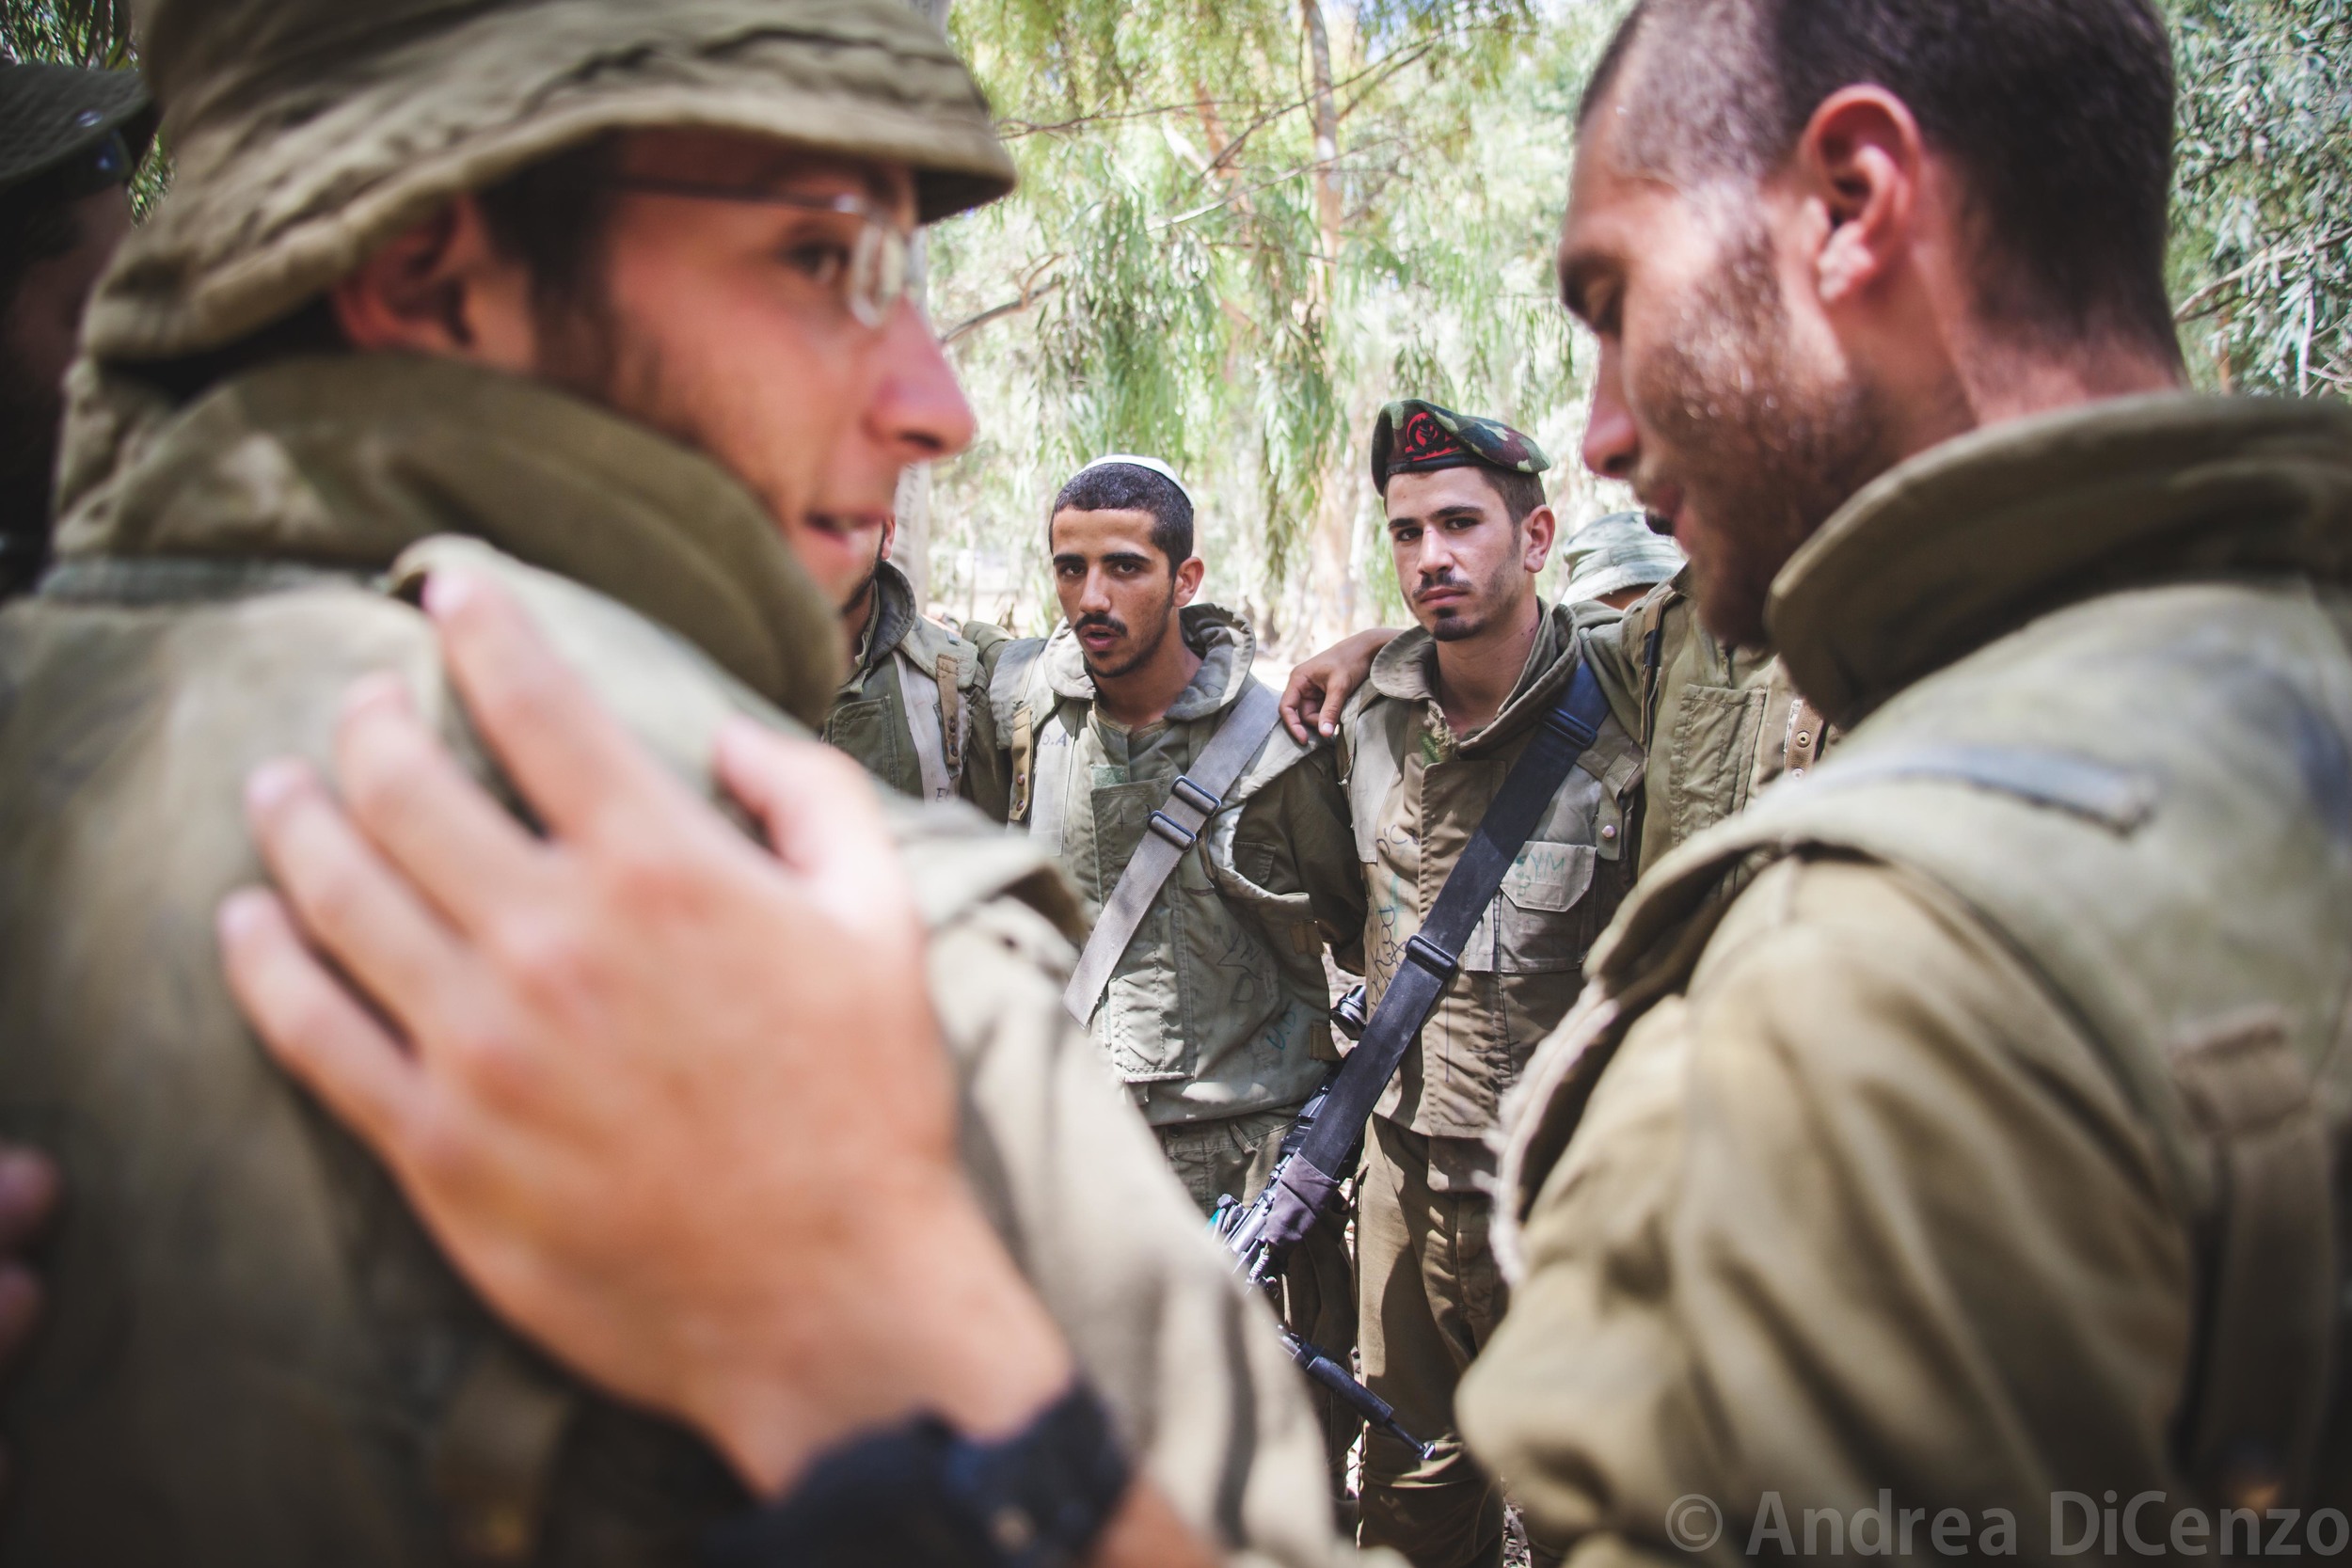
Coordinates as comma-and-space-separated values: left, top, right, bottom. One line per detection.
1499, 578, 2352, 1507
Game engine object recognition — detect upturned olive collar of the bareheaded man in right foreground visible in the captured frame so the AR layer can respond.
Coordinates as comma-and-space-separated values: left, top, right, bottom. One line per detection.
1767, 392, 2352, 726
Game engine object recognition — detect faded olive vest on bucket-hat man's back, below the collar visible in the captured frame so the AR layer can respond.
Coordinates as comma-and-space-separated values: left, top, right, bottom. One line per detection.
0, 538, 1071, 1568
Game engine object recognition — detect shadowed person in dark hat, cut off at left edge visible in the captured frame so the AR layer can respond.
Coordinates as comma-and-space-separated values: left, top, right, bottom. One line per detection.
0, 63, 155, 599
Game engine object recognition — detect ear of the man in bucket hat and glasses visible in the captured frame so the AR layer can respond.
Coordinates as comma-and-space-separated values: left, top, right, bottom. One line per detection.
329, 195, 536, 373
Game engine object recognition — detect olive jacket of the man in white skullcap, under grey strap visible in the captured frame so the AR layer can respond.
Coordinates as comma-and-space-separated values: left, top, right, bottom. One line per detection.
997, 604, 1364, 1126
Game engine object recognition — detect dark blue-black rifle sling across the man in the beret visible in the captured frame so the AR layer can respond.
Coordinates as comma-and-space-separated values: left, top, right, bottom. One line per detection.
1268, 663, 1609, 1212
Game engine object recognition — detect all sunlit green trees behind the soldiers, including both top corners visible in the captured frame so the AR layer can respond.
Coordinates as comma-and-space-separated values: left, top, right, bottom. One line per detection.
0, 0, 2352, 658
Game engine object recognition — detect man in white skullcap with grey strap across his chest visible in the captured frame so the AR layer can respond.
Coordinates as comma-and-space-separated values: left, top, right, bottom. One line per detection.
993, 456, 1364, 1479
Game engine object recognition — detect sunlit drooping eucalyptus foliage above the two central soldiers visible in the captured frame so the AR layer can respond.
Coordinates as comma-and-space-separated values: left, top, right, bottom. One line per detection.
931, 0, 1609, 632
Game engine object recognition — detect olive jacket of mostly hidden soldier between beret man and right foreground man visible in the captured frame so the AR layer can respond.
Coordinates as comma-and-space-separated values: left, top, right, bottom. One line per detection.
1583, 566, 1837, 870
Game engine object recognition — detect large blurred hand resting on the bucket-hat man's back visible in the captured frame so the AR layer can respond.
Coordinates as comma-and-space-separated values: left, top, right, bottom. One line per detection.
221, 576, 1071, 1491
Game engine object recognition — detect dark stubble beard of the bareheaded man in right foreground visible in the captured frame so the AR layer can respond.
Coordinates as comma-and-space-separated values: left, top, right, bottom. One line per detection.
1635, 223, 1889, 649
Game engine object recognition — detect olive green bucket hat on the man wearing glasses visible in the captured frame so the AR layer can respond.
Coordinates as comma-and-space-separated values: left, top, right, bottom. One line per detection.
85, 0, 1014, 362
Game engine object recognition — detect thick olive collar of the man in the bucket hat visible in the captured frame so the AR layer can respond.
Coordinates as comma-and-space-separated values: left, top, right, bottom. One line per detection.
59, 355, 842, 724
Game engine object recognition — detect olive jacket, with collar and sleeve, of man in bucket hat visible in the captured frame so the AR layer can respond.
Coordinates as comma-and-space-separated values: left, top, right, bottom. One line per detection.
0, 355, 1329, 1568
